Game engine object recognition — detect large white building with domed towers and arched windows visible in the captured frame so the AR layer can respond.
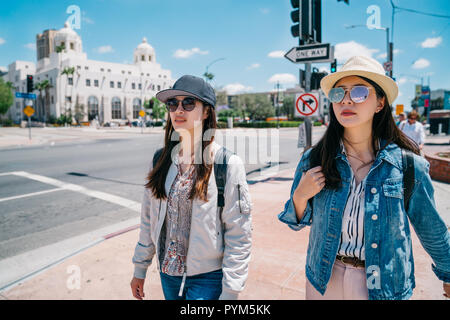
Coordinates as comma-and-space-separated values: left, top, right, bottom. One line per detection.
3, 24, 174, 124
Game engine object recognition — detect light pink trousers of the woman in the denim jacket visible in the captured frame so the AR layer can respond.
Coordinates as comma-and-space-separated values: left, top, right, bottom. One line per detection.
306, 260, 369, 300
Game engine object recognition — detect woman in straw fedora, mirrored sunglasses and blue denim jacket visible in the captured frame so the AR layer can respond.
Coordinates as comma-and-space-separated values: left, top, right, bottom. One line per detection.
278, 57, 450, 299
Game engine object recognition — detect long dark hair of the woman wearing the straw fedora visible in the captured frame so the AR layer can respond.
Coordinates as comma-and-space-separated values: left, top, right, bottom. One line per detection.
310, 76, 420, 189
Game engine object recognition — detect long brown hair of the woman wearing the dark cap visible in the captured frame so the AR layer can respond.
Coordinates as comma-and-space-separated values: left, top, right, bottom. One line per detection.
145, 103, 217, 201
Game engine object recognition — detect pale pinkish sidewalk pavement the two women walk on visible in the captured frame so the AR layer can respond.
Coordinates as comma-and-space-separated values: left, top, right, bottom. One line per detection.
0, 169, 450, 300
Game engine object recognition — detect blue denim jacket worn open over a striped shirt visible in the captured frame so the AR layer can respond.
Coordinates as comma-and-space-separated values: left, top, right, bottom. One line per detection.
278, 141, 450, 300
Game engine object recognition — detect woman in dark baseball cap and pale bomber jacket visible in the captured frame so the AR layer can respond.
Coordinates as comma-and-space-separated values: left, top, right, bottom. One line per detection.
131, 75, 251, 300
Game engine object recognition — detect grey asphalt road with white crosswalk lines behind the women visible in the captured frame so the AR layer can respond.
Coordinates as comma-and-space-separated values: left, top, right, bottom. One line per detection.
0, 128, 324, 260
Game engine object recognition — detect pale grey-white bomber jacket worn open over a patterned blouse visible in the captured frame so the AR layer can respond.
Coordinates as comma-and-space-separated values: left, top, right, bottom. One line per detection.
132, 142, 252, 299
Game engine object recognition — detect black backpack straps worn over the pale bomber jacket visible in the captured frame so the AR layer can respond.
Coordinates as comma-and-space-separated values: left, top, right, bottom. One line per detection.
153, 147, 233, 212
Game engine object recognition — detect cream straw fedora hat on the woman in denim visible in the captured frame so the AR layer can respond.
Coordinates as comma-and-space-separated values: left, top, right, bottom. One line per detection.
320, 56, 398, 105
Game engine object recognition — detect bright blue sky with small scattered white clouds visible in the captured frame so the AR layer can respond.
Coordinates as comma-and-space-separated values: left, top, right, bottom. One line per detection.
0, 0, 450, 109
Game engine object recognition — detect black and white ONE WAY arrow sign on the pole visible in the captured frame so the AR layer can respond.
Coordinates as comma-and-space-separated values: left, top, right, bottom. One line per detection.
284, 43, 334, 63
